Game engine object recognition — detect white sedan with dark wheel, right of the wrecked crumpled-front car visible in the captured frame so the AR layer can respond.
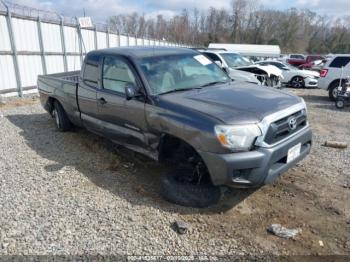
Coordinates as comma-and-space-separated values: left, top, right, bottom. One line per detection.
257, 60, 320, 88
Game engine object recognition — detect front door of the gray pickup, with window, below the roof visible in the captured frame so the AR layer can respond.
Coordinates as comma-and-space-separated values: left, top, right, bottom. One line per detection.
97, 55, 147, 153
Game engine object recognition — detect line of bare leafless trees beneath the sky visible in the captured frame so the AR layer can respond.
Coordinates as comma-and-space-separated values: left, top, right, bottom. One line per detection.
108, 0, 350, 54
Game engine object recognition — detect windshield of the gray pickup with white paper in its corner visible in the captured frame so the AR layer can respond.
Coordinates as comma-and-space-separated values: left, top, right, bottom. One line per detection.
140, 54, 231, 95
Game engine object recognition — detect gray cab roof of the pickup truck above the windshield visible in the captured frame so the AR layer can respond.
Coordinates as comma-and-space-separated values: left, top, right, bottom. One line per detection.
90, 46, 198, 58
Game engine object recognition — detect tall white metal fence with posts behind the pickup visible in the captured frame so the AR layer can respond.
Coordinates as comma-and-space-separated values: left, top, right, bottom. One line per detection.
0, 0, 189, 96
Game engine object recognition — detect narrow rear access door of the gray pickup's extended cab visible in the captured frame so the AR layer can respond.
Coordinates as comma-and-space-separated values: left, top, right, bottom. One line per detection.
78, 54, 101, 132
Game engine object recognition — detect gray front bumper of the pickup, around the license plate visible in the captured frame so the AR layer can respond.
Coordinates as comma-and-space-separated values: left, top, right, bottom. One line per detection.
200, 127, 312, 188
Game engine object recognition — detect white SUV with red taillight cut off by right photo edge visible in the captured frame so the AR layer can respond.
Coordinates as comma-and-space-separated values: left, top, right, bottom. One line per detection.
318, 54, 350, 101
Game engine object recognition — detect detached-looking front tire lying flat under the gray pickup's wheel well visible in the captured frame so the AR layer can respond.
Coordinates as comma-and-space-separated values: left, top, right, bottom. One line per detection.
160, 169, 221, 208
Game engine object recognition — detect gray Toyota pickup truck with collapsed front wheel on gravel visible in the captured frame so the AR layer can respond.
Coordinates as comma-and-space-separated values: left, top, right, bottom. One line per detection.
38, 47, 312, 207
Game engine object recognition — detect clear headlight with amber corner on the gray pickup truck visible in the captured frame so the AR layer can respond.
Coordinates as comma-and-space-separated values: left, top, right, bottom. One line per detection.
215, 124, 261, 151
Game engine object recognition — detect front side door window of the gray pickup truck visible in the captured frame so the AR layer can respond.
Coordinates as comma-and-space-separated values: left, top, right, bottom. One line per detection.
102, 57, 136, 94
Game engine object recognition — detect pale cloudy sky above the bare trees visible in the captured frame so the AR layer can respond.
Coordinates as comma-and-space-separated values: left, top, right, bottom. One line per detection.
6, 0, 350, 21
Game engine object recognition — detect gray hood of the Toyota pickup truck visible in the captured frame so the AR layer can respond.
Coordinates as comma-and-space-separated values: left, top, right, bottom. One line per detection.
159, 82, 301, 124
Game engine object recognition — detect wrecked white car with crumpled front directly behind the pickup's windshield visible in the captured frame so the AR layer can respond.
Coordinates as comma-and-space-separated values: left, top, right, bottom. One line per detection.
201, 50, 282, 87
